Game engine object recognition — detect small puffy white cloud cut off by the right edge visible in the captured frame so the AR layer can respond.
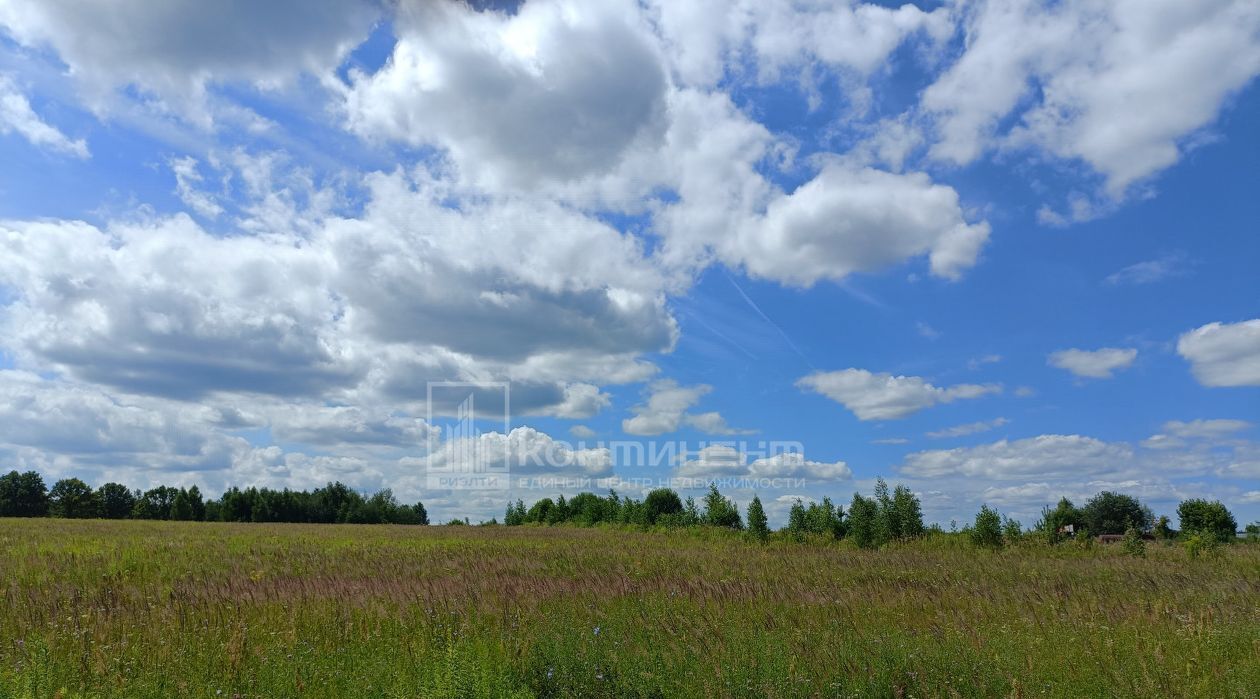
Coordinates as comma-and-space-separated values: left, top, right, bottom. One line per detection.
1177, 319, 1260, 387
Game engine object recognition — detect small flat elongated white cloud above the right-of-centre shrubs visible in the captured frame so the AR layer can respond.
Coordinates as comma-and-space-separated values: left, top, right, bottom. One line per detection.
796, 369, 1002, 419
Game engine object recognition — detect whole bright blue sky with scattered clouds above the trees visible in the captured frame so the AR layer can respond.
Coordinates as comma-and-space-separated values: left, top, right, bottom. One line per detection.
0, 0, 1260, 524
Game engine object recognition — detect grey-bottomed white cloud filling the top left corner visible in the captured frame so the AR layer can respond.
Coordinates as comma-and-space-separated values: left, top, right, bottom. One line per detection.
0, 0, 381, 126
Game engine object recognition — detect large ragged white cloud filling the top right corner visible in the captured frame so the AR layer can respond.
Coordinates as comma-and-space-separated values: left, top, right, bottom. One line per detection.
922, 0, 1260, 198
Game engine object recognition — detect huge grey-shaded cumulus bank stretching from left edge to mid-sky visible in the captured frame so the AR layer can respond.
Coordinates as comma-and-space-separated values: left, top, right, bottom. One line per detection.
0, 161, 677, 418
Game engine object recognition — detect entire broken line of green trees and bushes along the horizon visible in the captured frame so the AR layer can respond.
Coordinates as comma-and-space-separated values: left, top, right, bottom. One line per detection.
0, 471, 1244, 550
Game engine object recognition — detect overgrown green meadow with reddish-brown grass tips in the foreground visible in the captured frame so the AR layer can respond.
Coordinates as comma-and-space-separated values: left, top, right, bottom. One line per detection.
0, 519, 1260, 698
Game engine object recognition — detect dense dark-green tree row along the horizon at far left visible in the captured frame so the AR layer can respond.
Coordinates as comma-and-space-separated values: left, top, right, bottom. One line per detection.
0, 471, 428, 524
